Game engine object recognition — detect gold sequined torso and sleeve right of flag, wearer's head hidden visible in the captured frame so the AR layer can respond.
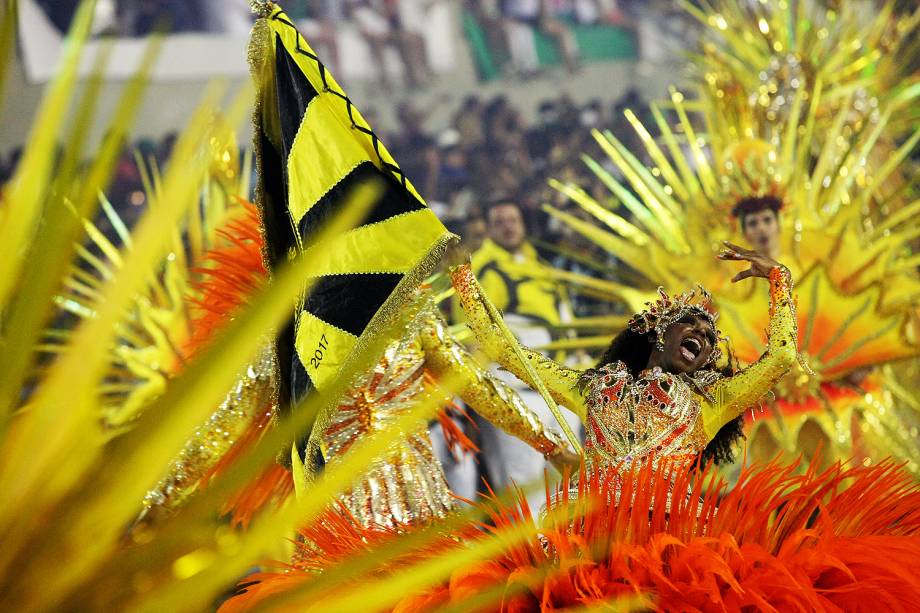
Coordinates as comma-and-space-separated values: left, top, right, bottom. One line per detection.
322, 295, 564, 526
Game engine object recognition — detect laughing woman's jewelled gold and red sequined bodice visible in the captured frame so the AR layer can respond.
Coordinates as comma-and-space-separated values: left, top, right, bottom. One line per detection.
585, 362, 707, 466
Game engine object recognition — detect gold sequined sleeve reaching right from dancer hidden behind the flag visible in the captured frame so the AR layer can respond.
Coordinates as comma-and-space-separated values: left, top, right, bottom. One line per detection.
419, 305, 565, 455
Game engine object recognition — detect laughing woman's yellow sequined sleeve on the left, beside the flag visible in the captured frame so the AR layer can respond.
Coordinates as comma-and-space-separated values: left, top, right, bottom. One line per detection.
450, 264, 586, 421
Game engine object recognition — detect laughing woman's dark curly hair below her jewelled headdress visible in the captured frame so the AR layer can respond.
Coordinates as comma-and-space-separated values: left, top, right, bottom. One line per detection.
597, 328, 744, 466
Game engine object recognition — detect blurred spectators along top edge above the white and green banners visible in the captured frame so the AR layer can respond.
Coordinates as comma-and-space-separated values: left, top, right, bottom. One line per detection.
36, 0, 673, 88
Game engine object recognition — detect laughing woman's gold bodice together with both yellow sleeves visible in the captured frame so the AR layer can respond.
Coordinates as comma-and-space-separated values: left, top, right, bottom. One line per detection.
452, 265, 797, 467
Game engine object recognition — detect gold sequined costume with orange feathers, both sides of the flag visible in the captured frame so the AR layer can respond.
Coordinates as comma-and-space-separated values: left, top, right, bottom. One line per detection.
137, 219, 564, 526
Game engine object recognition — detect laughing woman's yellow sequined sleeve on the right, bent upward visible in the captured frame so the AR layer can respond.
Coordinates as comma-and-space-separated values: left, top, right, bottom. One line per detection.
703, 266, 798, 438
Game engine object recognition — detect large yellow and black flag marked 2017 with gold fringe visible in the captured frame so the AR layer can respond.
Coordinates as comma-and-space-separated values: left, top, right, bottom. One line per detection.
249, 2, 454, 460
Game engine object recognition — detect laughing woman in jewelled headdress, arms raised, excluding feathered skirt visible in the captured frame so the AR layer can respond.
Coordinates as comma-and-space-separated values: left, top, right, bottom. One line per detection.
451, 243, 797, 469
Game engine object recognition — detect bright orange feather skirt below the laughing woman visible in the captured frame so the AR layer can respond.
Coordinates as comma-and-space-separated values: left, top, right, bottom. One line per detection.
223, 461, 920, 613
